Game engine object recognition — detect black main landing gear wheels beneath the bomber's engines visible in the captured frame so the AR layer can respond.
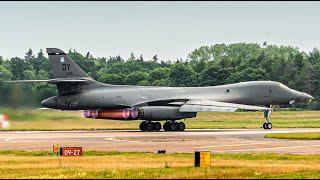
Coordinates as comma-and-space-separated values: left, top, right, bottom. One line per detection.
140, 121, 186, 131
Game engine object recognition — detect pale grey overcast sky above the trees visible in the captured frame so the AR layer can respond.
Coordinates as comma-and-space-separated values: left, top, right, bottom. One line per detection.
0, 2, 320, 60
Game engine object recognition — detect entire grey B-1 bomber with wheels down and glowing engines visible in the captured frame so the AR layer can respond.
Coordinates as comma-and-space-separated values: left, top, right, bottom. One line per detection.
5, 48, 314, 131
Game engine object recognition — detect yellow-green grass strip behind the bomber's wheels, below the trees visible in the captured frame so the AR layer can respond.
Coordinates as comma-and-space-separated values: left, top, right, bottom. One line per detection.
0, 108, 320, 130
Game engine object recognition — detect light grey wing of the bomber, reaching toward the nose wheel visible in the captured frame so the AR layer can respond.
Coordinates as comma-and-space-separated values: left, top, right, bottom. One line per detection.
180, 100, 270, 112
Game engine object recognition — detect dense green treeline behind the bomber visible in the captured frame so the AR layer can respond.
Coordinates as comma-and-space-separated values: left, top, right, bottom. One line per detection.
0, 43, 320, 106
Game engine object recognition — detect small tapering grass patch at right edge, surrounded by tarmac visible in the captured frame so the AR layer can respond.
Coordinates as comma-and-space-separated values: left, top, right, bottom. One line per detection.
265, 132, 320, 140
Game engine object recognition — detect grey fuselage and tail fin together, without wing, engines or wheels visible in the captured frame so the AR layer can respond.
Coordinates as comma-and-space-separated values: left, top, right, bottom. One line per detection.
42, 48, 313, 110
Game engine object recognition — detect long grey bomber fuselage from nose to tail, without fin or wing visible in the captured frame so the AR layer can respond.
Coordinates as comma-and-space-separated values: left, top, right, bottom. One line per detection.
42, 81, 312, 110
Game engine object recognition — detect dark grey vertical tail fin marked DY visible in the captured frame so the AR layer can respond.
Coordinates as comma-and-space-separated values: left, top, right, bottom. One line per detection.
47, 48, 88, 78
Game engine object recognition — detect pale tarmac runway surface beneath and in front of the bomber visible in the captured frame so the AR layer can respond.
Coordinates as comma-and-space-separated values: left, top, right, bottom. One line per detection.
0, 128, 320, 154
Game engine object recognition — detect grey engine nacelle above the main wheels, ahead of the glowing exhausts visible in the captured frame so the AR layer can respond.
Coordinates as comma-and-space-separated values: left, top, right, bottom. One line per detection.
139, 106, 197, 120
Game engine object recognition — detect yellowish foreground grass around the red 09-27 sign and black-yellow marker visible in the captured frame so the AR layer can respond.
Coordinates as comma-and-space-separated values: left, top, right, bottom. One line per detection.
0, 150, 320, 178
